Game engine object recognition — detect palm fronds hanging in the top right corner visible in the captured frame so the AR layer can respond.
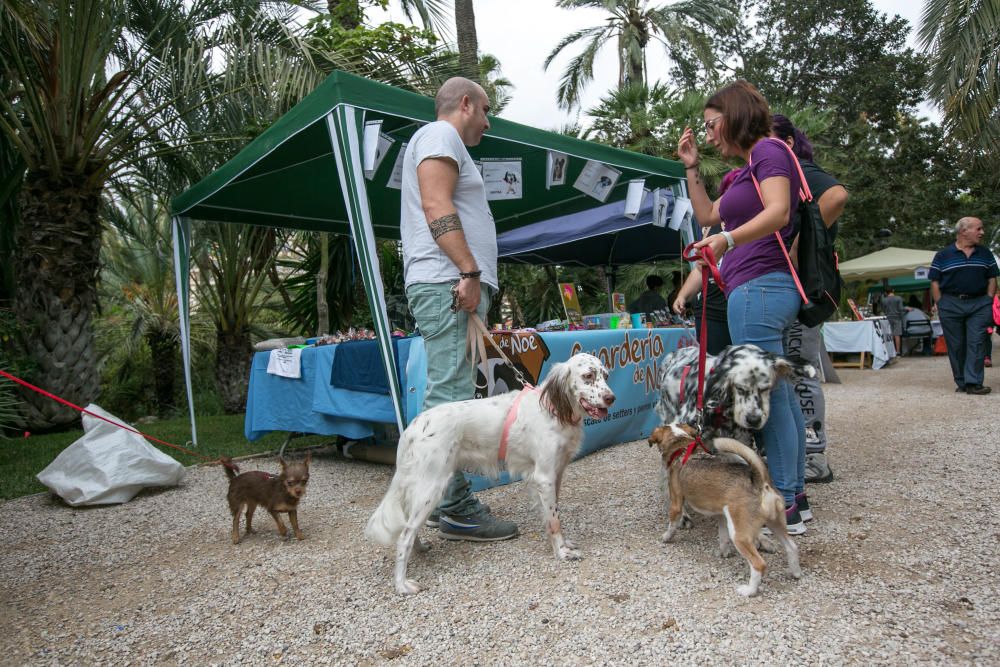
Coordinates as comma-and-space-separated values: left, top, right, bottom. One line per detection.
920, 0, 1000, 151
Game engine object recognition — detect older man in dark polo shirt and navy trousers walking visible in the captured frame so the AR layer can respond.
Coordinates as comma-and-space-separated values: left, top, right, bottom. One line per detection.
929, 218, 998, 394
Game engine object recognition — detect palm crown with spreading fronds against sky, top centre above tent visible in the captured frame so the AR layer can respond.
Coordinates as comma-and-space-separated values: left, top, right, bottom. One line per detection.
543, 0, 733, 109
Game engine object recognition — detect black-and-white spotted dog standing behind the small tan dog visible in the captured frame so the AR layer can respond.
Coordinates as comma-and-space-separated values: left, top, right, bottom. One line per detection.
656, 345, 816, 445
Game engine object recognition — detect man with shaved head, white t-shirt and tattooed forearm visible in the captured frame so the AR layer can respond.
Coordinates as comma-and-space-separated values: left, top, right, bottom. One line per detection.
400, 77, 517, 542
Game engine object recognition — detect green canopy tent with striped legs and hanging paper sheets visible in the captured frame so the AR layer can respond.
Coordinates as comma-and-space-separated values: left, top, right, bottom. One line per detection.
171, 72, 684, 442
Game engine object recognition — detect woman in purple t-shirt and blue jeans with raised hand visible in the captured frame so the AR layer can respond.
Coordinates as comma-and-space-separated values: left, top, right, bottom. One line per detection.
677, 81, 806, 535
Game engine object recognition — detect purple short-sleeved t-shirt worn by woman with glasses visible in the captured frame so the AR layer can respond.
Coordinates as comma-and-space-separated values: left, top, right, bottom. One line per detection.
719, 139, 800, 296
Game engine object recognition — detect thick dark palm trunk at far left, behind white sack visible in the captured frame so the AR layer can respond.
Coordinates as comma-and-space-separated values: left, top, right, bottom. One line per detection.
14, 172, 101, 430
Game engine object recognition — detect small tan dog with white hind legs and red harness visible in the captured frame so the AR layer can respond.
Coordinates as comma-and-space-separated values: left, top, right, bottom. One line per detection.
649, 424, 801, 597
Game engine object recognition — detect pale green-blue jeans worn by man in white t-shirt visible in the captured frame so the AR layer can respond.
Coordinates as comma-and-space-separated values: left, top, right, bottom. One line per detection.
406, 283, 491, 517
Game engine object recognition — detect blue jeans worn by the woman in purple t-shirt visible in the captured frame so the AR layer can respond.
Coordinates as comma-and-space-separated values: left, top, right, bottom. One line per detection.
728, 272, 806, 505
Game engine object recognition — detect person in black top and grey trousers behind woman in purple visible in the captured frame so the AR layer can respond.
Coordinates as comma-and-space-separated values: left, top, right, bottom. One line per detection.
771, 114, 848, 482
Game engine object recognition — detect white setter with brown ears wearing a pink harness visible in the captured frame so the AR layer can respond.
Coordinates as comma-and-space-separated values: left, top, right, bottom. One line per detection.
365, 354, 615, 594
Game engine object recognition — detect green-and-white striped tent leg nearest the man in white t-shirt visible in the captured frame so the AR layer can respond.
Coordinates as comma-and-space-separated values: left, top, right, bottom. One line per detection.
326, 104, 406, 433
